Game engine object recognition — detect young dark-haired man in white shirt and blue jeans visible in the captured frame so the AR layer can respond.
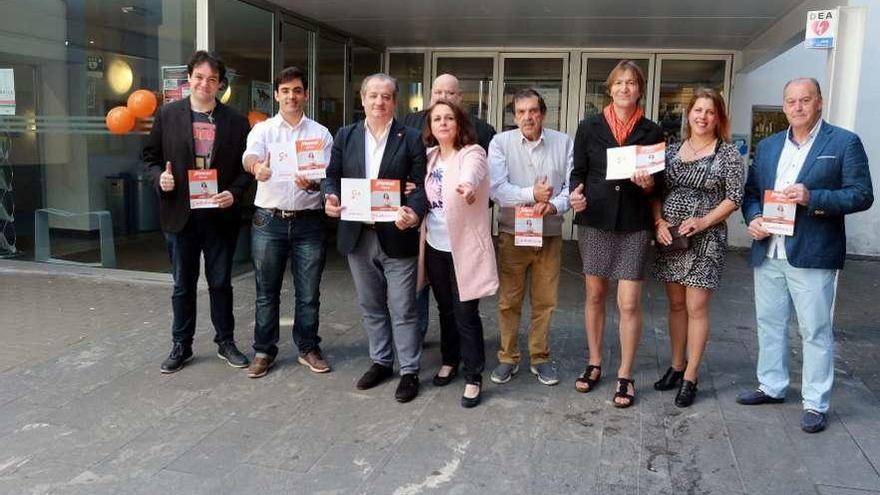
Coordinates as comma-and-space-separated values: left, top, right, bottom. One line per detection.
242, 67, 333, 378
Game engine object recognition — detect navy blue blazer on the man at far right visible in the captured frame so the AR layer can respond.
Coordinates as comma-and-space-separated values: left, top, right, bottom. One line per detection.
743, 121, 874, 270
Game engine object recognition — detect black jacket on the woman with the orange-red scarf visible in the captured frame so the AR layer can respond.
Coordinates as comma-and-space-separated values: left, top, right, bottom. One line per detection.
568, 113, 663, 232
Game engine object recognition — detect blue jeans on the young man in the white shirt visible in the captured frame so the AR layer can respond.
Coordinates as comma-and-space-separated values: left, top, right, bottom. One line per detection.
251, 208, 327, 358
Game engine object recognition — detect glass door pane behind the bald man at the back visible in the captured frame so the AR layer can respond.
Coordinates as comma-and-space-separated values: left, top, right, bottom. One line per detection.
437, 57, 495, 120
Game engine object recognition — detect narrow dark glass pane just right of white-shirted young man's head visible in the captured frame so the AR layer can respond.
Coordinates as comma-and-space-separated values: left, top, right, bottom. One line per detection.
316, 37, 345, 135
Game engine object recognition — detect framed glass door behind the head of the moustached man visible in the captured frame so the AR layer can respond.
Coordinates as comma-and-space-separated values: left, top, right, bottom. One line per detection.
497, 53, 568, 132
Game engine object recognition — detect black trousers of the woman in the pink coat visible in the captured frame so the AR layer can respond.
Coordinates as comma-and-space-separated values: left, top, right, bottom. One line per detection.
425, 244, 486, 381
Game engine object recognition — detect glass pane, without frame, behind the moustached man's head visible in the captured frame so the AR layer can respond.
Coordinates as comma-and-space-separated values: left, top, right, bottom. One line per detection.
502, 58, 565, 131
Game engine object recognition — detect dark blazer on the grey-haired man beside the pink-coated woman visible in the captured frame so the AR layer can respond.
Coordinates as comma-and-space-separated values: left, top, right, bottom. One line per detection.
321, 120, 428, 258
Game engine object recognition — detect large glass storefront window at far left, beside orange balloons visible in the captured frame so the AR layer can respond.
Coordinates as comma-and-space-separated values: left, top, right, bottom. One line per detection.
0, 0, 196, 271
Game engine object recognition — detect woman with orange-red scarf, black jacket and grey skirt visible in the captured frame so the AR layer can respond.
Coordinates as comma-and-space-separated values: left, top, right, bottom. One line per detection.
569, 60, 663, 408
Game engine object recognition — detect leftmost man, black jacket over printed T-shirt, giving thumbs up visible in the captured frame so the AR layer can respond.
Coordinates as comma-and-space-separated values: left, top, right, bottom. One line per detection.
143, 51, 251, 373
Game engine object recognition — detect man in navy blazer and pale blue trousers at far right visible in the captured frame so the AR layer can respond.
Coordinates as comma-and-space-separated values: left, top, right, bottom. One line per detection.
737, 79, 874, 433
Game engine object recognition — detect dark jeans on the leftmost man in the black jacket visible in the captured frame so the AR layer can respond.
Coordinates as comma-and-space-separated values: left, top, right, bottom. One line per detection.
165, 211, 239, 346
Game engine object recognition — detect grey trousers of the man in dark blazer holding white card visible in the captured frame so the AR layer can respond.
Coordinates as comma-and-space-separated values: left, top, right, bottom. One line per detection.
348, 229, 422, 375
